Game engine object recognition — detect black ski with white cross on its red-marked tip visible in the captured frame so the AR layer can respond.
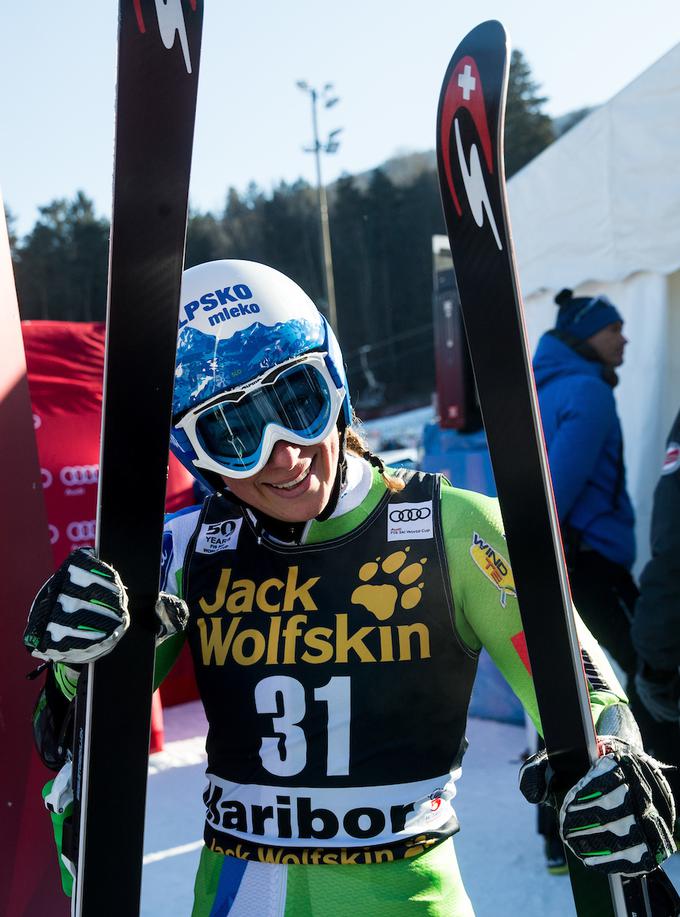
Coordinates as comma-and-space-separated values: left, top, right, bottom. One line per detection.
437, 21, 676, 917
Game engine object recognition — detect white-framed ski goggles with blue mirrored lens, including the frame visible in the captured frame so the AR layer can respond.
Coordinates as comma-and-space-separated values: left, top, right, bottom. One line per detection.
175, 353, 344, 478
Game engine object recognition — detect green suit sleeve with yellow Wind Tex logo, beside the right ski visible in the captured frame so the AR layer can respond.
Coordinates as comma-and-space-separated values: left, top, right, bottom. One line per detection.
441, 484, 627, 734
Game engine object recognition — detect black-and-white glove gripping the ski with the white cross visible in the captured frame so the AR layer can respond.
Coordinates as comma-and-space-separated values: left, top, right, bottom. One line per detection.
520, 736, 675, 876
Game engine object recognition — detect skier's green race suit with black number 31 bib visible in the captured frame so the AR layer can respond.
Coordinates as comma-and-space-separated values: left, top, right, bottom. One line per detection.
157, 456, 625, 917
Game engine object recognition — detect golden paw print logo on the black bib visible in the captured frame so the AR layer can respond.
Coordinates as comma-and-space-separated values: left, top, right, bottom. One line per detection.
351, 548, 427, 621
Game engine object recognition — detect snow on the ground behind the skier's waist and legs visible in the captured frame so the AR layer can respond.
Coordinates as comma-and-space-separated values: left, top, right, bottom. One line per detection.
142, 702, 680, 917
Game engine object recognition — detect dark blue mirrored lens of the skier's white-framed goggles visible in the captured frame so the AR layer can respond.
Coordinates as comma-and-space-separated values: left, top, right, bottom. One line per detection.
196, 366, 331, 469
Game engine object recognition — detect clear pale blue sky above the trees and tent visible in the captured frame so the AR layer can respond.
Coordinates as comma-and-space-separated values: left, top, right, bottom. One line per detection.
0, 0, 680, 234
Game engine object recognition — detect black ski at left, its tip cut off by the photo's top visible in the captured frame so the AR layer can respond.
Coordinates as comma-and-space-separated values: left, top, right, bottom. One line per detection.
74, 0, 203, 917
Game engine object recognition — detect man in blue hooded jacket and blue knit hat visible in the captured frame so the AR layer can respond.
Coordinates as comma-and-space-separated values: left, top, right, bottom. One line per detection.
533, 290, 649, 872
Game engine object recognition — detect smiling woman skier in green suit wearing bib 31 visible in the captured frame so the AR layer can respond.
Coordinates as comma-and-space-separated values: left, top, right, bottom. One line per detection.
26, 261, 674, 917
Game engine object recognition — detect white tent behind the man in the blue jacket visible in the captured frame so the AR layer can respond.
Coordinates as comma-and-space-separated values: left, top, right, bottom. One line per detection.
508, 45, 680, 572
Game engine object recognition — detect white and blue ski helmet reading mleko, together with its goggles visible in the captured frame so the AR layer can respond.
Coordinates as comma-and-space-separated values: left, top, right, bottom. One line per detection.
170, 260, 352, 489
